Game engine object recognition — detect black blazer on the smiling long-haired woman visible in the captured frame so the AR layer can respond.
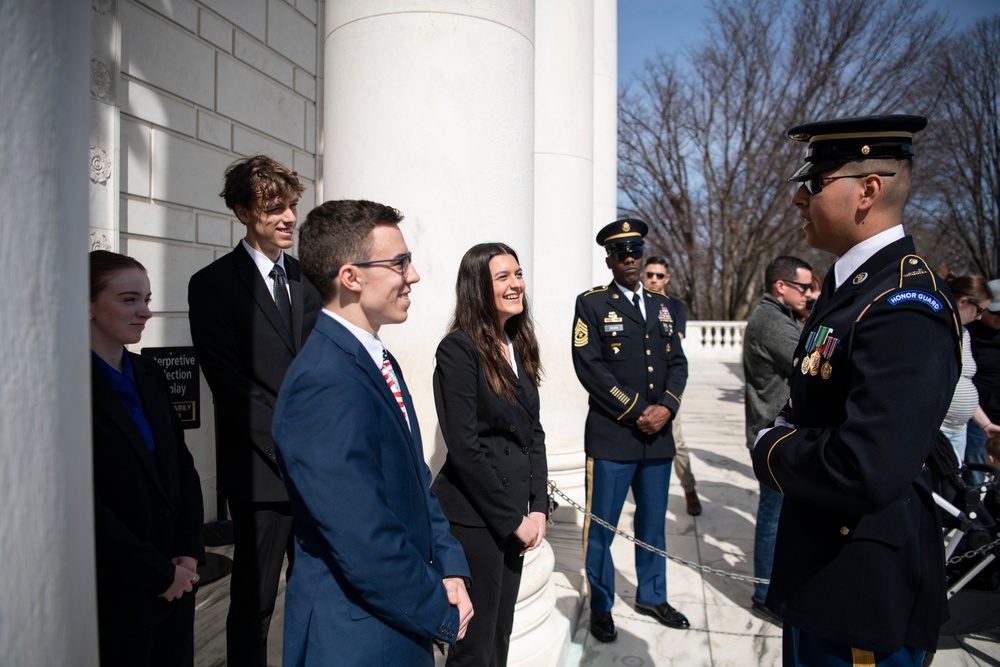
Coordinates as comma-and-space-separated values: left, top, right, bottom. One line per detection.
431, 331, 548, 539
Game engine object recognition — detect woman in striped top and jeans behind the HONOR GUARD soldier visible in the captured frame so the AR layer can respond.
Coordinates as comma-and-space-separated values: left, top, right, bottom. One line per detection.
941, 276, 1000, 465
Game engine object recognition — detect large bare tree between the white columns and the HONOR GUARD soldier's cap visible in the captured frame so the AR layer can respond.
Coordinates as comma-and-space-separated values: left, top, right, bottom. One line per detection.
618, 0, 943, 319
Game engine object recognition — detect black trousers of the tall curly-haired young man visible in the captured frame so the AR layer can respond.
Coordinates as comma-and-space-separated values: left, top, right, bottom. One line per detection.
226, 501, 295, 667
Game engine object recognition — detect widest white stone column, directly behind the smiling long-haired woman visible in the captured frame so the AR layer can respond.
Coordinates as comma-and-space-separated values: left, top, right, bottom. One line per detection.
323, 0, 568, 666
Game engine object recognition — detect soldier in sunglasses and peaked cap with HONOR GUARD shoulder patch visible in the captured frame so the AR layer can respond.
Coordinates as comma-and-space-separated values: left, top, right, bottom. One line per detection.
753, 115, 960, 666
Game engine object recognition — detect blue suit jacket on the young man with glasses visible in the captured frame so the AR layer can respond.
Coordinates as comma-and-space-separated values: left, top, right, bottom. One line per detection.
274, 314, 469, 666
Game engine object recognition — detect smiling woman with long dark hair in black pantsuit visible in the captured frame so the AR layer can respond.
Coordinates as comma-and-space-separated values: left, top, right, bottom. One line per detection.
432, 243, 548, 667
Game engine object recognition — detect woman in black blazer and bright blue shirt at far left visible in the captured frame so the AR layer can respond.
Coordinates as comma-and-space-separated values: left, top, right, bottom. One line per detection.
90, 250, 205, 667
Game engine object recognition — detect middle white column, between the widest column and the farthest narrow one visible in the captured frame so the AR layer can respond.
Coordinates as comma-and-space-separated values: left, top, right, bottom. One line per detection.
535, 0, 594, 525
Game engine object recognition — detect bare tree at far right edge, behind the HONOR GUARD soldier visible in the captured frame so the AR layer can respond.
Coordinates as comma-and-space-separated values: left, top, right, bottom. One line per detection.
915, 16, 1000, 278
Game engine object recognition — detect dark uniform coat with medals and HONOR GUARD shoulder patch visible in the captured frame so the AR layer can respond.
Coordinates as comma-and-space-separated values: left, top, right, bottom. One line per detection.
753, 237, 960, 651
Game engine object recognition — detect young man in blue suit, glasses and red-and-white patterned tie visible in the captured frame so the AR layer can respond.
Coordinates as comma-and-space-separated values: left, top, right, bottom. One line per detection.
274, 201, 472, 667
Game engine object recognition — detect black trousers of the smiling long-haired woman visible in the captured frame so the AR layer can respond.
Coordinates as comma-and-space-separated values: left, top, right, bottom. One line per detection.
448, 523, 524, 667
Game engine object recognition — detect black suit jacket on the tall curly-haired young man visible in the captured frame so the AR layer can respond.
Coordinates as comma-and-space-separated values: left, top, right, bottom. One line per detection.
188, 242, 322, 502
